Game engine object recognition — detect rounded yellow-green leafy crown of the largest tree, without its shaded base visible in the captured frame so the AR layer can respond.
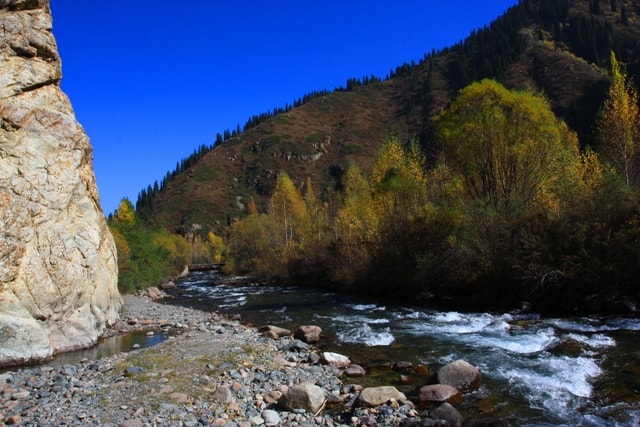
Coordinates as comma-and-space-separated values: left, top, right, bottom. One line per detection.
436, 80, 576, 219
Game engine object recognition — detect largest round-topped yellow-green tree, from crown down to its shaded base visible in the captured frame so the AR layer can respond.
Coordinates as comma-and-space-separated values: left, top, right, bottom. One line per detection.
435, 80, 578, 292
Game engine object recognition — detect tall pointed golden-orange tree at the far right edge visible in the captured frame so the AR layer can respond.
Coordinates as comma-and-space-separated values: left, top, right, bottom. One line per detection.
596, 51, 640, 185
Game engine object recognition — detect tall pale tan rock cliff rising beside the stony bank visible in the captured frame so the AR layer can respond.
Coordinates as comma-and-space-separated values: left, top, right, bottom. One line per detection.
0, 0, 121, 366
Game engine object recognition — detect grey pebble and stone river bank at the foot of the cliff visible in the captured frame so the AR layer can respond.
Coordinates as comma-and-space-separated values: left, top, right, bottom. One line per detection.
0, 295, 476, 427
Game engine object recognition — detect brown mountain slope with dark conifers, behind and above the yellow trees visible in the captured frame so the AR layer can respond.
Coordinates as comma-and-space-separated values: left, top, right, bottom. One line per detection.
147, 0, 640, 237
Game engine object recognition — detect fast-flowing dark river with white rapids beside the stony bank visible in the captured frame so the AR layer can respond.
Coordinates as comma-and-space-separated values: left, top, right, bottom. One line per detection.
162, 271, 640, 426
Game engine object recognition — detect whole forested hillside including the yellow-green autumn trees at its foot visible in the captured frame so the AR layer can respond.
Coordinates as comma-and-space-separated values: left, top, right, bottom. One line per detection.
111, 0, 640, 314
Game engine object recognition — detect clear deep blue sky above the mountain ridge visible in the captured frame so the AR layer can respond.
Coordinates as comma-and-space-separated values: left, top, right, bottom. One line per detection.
51, 0, 517, 214
